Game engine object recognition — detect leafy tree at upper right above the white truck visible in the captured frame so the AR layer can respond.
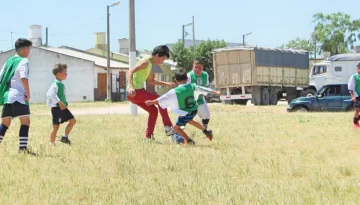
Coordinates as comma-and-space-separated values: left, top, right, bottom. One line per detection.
313, 12, 360, 55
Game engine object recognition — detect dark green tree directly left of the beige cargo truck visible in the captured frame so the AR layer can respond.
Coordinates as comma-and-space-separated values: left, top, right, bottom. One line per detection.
170, 40, 227, 81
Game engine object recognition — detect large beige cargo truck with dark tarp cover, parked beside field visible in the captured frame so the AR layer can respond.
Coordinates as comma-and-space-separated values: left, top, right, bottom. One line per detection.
212, 46, 309, 105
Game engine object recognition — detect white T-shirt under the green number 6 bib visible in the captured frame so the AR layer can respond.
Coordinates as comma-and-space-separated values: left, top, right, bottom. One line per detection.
157, 85, 212, 116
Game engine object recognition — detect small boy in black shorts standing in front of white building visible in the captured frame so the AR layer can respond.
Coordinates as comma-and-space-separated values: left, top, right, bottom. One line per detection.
46, 64, 76, 146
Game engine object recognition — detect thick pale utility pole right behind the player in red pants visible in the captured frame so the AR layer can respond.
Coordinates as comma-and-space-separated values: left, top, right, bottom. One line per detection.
126, 0, 138, 116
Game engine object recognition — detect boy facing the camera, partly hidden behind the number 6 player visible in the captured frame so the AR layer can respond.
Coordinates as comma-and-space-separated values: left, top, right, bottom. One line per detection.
187, 60, 210, 128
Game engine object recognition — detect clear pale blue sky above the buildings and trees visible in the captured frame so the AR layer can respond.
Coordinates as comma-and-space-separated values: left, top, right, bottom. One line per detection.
0, 0, 360, 52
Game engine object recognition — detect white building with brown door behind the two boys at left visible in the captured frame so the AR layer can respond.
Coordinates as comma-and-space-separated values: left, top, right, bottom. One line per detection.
0, 26, 129, 103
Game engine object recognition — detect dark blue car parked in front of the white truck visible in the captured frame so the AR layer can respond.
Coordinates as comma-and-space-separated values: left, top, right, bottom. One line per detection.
287, 84, 353, 112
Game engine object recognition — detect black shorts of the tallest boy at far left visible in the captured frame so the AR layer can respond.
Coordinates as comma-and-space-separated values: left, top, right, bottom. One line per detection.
1, 101, 30, 118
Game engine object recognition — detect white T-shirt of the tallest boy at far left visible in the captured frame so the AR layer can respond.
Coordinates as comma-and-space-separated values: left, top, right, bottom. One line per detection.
0, 55, 30, 104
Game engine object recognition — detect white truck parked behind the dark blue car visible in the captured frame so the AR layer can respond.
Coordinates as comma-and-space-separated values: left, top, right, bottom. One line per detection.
301, 53, 360, 96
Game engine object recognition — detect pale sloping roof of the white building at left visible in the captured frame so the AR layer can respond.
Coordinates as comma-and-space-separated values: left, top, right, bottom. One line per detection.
42, 47, 129, 69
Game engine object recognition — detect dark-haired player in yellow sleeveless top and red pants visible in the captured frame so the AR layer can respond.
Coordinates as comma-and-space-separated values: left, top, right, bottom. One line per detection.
127, 45, 176, 140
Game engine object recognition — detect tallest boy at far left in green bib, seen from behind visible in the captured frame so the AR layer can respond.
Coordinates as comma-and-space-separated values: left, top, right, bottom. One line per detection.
0, 38, 34, 154
